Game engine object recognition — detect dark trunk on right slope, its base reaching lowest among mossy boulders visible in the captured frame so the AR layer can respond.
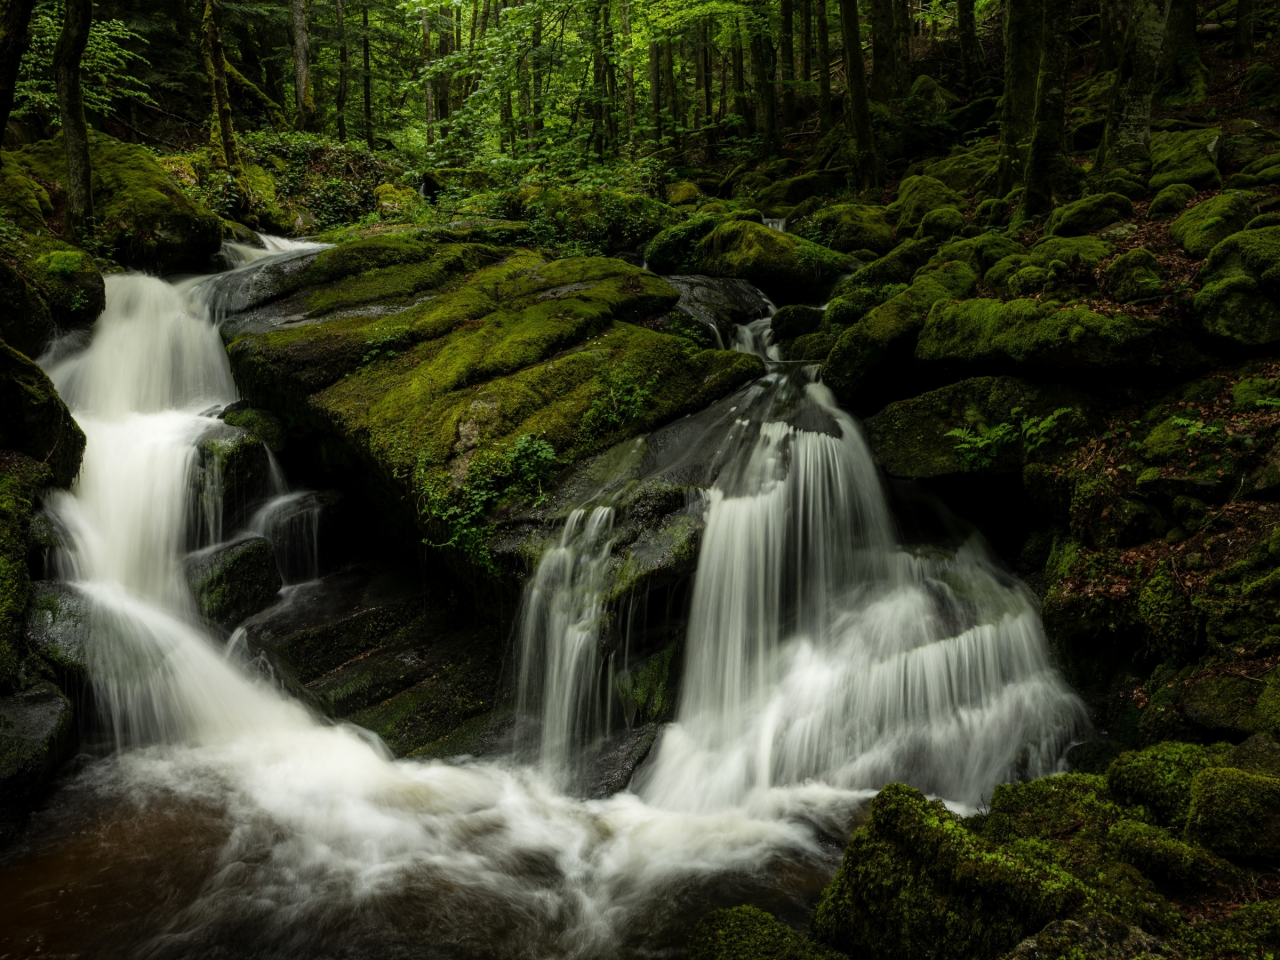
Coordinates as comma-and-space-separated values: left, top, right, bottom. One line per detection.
1021, 0, 1071, 218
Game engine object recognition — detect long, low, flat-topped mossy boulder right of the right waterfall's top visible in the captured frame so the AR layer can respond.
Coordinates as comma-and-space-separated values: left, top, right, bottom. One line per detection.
915, 300, 1198, 375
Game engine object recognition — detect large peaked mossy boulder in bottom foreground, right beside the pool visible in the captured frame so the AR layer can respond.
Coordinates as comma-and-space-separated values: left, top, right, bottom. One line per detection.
812, 785, 1085, 960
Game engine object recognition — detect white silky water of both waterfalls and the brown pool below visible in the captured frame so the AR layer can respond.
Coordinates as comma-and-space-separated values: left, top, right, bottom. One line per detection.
0, 251, 1084, 960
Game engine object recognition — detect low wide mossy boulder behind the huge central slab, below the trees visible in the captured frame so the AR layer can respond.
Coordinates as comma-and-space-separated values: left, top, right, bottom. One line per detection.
507, 187, 684, 253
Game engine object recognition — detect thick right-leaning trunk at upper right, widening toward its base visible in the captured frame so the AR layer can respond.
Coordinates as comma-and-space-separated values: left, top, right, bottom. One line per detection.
1094, 0, 1170, 173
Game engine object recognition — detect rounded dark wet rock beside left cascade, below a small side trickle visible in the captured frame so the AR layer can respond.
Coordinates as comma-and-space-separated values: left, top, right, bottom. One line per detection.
184, 536, 280, 628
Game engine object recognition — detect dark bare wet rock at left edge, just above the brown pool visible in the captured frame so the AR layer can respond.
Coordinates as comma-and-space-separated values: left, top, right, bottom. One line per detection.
0, 684, 76, 837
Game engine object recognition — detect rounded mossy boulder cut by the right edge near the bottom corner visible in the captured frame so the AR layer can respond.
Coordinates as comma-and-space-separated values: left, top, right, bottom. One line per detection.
1187, 767, 1280, 860
